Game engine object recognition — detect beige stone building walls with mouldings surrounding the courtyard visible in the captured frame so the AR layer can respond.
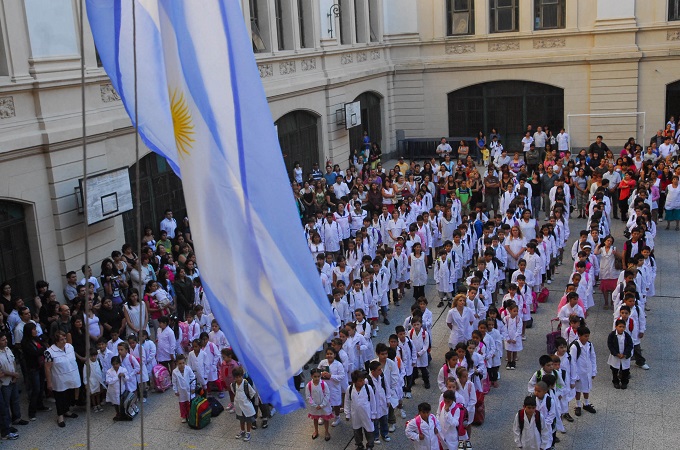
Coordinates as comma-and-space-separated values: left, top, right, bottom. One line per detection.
0, 0, 680, 298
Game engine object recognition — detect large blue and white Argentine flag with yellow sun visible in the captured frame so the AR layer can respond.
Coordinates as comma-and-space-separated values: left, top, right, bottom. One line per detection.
87, 0, 338, 412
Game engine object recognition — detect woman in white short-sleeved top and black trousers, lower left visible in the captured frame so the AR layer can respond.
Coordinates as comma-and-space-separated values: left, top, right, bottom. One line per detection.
45, 331, 81, 428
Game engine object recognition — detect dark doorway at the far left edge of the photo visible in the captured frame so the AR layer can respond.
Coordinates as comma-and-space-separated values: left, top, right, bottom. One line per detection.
0, 201, 35, 303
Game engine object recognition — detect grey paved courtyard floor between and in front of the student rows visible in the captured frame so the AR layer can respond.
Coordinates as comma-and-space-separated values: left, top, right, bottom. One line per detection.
7, 216, 680, 450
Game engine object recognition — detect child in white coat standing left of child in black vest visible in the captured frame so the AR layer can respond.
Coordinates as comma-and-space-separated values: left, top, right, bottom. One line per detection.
569, 327, 597, 416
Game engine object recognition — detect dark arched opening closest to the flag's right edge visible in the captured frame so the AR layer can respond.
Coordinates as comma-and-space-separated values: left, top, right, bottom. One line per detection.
275, 110, 319, 179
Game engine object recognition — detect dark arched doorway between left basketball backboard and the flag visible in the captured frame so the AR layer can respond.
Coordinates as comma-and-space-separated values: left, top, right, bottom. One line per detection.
123, 153, 187, 246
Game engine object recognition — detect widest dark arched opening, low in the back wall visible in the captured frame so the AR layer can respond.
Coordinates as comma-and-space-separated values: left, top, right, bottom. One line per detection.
448, 81, 564, 150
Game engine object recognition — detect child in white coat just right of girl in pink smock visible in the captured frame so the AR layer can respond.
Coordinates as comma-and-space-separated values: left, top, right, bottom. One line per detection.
345, 370, 378, 448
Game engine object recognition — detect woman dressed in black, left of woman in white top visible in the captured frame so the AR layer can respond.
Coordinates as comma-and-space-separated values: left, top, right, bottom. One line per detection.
20, 322, 52, 420
